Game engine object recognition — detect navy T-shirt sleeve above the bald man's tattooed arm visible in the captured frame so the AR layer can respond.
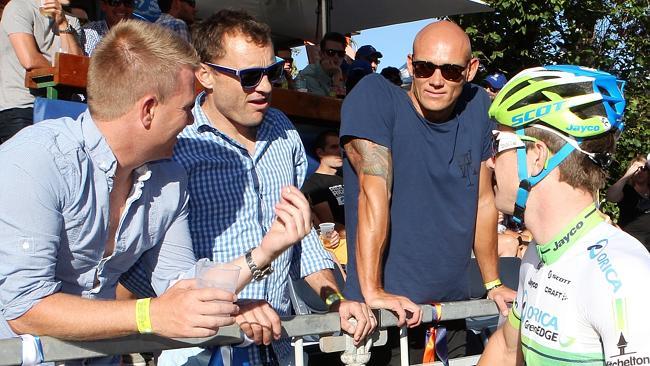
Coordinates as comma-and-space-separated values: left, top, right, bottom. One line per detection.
341, 74, 396, 149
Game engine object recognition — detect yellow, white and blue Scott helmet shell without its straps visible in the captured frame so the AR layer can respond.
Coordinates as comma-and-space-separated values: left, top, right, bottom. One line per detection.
489, 65, 625, 138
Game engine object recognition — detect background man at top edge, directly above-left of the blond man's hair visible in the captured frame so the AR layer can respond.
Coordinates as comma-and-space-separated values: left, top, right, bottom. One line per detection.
81, 0, 135, 56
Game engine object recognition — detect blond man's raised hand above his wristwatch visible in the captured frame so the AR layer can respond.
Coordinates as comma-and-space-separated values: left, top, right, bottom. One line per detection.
260, 187, 312, 258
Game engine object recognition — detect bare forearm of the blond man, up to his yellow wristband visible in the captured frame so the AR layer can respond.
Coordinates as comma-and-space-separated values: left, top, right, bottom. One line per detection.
8, 293, 137, 340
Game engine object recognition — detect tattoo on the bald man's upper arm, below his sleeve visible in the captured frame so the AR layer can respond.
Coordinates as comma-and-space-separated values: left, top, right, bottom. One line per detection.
345, 139, 393, 191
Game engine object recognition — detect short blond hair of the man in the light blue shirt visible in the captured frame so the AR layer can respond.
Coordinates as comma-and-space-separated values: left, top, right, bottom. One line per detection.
87, 20, 199, 120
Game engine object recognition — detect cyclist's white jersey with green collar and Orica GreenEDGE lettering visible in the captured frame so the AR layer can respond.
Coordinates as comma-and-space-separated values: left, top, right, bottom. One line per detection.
509, 206, 650, 366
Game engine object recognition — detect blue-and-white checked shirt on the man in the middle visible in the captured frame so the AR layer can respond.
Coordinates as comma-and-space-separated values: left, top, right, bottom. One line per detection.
174, 93, 334, 364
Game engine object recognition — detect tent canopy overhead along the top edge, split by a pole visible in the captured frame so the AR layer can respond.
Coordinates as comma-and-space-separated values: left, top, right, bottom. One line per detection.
197, 0, 492, 42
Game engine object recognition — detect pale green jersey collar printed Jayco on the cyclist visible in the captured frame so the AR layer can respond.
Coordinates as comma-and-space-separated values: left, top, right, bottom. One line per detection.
536, 204, 604, 265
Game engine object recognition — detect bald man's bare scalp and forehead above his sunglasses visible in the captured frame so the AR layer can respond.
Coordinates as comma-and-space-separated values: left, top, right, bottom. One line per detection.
413, 20, 472, 64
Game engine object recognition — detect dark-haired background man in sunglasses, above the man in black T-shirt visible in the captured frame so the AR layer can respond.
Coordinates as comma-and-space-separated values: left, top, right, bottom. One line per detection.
298, 32, 346, 96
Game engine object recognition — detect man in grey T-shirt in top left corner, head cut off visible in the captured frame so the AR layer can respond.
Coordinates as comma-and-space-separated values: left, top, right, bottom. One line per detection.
0, 0, 82, 144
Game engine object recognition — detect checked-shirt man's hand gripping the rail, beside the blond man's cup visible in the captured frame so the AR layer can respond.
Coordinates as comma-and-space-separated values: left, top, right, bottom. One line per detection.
235, 300, 282, 346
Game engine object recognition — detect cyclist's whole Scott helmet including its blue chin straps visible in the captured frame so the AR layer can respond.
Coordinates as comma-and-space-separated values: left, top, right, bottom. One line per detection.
488, 65, 625, 223
